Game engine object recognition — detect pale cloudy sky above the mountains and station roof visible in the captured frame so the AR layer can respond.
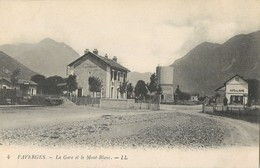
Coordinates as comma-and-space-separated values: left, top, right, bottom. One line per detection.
0, 0, 260, 72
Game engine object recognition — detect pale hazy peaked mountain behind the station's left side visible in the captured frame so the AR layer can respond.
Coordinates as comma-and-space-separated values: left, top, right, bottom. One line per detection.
0, 38, 79, 77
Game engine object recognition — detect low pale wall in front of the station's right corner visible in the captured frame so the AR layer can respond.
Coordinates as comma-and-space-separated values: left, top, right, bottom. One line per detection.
100, 98, 135, 109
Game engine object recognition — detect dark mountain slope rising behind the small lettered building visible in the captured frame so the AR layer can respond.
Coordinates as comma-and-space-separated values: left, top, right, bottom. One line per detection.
170, 31, 260, 95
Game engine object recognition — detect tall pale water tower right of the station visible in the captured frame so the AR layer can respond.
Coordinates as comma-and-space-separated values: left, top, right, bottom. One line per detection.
156, 66, 174, 102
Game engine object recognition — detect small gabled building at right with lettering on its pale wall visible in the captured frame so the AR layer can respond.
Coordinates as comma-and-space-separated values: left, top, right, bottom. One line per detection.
215, 75, 248, 105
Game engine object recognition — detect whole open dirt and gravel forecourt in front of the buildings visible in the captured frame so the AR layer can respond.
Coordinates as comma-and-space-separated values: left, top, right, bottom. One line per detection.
0, 104, 259, 148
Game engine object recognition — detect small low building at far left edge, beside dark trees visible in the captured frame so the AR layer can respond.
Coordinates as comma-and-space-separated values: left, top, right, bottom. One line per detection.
0, 77, 38, 96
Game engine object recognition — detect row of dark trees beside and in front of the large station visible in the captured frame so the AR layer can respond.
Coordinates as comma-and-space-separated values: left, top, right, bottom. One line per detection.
30, 72, 162, 100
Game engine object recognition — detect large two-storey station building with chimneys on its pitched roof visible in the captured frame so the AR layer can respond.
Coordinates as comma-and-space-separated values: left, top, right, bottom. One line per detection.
67, 49, 129, 98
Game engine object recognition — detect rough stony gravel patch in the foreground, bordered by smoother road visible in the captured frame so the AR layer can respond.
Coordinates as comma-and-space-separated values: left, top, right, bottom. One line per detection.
0, 112, 230, 148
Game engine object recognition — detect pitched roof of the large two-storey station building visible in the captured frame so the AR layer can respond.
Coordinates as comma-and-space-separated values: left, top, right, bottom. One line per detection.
68, 51, 130, 72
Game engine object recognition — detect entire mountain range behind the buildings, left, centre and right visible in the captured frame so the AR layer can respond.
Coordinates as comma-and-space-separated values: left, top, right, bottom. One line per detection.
0, 31, 260, 95
